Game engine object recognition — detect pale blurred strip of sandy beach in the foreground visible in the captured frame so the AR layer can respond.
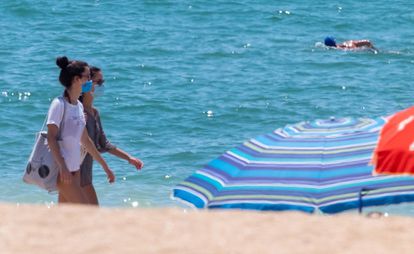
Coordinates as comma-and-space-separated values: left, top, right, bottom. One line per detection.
0, 204, 414, 254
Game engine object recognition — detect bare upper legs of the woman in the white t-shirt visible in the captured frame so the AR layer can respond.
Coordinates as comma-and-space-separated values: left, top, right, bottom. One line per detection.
57, 171, 88, 204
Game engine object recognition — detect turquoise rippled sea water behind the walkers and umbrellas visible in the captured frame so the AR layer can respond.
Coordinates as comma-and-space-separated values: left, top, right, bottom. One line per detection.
0, 0, 414, 216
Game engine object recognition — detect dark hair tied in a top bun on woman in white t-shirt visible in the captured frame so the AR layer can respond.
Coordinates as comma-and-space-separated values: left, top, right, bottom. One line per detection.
56, 56, 88, 88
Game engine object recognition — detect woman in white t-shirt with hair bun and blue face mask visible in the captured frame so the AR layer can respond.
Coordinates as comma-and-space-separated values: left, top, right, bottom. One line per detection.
47, 56, 115, 204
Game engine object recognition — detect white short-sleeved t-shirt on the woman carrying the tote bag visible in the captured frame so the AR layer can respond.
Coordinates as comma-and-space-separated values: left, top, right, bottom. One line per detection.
47, 98, 86, 172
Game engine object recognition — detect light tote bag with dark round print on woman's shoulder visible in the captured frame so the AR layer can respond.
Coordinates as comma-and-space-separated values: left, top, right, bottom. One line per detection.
23, 97, 65, 192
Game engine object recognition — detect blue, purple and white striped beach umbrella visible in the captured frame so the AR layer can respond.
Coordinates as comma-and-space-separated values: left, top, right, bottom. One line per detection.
172, 118, 414, 213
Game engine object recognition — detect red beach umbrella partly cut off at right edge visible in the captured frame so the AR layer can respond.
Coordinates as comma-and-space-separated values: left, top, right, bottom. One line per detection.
372, 107, 414, 175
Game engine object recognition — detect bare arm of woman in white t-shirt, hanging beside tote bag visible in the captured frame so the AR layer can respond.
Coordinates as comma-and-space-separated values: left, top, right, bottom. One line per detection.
47, 124, 72, 184
